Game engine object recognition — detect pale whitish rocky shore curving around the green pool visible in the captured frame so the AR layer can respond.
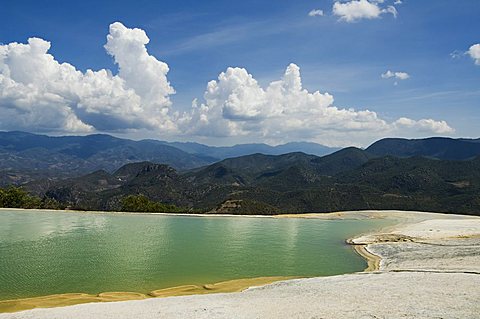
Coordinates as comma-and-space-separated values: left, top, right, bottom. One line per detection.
0, 211, 480, 318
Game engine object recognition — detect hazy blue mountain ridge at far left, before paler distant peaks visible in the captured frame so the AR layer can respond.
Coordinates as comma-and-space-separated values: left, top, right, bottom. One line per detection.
0, 132, 216, 185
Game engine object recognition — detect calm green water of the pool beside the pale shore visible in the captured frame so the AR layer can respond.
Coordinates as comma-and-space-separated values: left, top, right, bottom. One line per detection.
0, 211, 386, 300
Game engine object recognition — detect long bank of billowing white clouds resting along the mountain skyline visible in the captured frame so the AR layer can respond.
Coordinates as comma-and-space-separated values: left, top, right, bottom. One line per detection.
0, 22, 454, 146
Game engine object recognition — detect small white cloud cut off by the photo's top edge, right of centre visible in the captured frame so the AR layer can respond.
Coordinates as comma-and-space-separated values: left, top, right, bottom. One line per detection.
332, 0, 397, 22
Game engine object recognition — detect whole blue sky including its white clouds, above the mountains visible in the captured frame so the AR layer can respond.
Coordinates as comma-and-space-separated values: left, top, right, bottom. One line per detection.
0, 0, 480, 147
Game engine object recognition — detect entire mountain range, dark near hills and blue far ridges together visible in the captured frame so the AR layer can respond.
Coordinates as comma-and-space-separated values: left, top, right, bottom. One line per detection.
0, 132, 480, 214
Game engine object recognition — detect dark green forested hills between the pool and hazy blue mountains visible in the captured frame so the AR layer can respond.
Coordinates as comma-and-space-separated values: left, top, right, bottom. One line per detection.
20, 139, 480, 215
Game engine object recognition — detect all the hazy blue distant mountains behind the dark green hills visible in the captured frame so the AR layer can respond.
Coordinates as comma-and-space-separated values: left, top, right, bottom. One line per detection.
0, 132, 337, 186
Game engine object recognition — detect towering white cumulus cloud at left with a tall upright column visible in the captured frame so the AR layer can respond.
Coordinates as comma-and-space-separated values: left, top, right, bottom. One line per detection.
0, 22, 175, 132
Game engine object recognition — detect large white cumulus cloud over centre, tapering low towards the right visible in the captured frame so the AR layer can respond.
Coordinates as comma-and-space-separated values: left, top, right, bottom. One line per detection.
183, 64, 454, 145
